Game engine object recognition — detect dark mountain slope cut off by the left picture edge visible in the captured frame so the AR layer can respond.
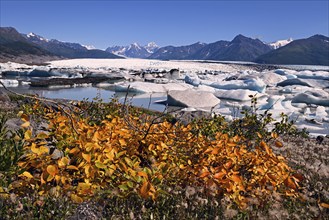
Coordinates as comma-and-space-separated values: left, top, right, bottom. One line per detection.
0, 27, 58, 63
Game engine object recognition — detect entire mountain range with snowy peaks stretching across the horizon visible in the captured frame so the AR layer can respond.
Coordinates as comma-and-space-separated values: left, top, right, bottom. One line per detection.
0, 27, 329, 66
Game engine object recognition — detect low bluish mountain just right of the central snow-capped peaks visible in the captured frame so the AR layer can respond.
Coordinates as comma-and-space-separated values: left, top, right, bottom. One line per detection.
148, 42, 206, 60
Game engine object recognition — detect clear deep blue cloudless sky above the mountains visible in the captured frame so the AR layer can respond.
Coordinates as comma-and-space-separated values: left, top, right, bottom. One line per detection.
0, 0, 329, 49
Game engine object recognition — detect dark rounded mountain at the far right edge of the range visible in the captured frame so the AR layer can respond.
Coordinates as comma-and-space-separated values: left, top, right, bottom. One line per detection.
256, 35, 329, 66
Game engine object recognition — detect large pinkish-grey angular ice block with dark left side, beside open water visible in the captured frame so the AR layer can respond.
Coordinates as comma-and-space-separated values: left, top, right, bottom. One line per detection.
167, 89, 220, 108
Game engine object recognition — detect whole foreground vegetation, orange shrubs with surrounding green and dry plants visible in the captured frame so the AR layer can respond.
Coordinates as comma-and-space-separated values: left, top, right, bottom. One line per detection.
0, 93, 329, 219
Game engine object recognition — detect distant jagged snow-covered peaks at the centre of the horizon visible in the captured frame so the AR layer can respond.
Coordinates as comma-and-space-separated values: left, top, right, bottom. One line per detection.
106, 42, 159, 58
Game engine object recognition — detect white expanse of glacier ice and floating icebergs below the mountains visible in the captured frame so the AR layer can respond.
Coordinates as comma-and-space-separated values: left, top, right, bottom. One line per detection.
0, 59, 329, 138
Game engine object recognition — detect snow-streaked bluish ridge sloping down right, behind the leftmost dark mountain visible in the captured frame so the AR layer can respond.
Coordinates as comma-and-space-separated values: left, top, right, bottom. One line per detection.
22, 33, 121, 59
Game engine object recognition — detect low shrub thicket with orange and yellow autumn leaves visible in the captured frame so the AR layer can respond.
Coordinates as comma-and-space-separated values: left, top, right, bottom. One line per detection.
2, 99, 302, 211
